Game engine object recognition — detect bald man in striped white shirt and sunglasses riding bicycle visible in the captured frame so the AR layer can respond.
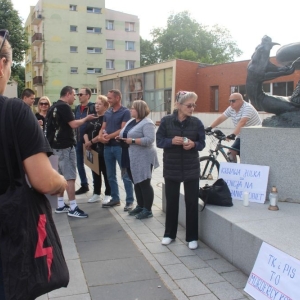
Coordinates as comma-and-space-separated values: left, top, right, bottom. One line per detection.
205, 93, 261, 162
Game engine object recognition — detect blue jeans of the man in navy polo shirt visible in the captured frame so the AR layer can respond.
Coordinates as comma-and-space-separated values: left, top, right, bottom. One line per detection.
104, 146, 134, 204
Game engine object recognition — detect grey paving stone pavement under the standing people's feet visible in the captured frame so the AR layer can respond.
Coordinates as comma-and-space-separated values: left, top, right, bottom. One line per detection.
38, 144, 253, 300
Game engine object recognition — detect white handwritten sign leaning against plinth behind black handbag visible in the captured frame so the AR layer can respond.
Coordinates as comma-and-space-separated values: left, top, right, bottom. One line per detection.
219, 162, 269, 203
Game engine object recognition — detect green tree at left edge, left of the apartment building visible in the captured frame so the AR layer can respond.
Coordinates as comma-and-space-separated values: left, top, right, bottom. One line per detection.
0, 0, 29, 85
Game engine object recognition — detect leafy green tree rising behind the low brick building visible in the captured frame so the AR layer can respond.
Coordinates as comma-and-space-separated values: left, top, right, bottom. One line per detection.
141, 11, 242, 64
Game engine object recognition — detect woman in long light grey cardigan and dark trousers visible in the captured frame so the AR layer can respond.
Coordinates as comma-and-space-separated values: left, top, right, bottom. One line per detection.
120, 100, 159, 219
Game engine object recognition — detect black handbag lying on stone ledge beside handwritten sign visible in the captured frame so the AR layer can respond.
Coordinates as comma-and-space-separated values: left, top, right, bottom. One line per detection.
199, 178, 233, 211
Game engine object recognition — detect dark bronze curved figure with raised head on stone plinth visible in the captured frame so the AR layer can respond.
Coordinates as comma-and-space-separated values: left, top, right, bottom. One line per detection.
246, 36, 300, 117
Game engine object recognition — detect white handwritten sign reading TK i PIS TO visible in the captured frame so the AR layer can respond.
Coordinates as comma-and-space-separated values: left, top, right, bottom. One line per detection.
245, 243, 300, 300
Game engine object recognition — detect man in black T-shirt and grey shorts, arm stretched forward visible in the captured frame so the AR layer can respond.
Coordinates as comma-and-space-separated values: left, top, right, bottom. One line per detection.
45, 86, 97, 218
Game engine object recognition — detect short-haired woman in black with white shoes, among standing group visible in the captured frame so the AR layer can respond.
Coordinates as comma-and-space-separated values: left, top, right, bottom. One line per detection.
83, 95, 111, 204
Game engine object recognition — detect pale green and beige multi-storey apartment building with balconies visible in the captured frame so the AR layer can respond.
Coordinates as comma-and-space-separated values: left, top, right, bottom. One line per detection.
25, 0, 140, 103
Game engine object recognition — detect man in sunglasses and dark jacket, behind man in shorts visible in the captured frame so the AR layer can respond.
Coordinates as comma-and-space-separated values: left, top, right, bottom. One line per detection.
75, 88, 95, 195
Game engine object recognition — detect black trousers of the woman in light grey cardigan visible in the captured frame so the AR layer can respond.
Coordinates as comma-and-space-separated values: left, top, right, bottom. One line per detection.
127, 165, 154, 211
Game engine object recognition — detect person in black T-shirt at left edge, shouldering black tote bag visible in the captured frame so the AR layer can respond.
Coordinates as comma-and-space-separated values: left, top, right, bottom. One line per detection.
0, 30, 67, 300
